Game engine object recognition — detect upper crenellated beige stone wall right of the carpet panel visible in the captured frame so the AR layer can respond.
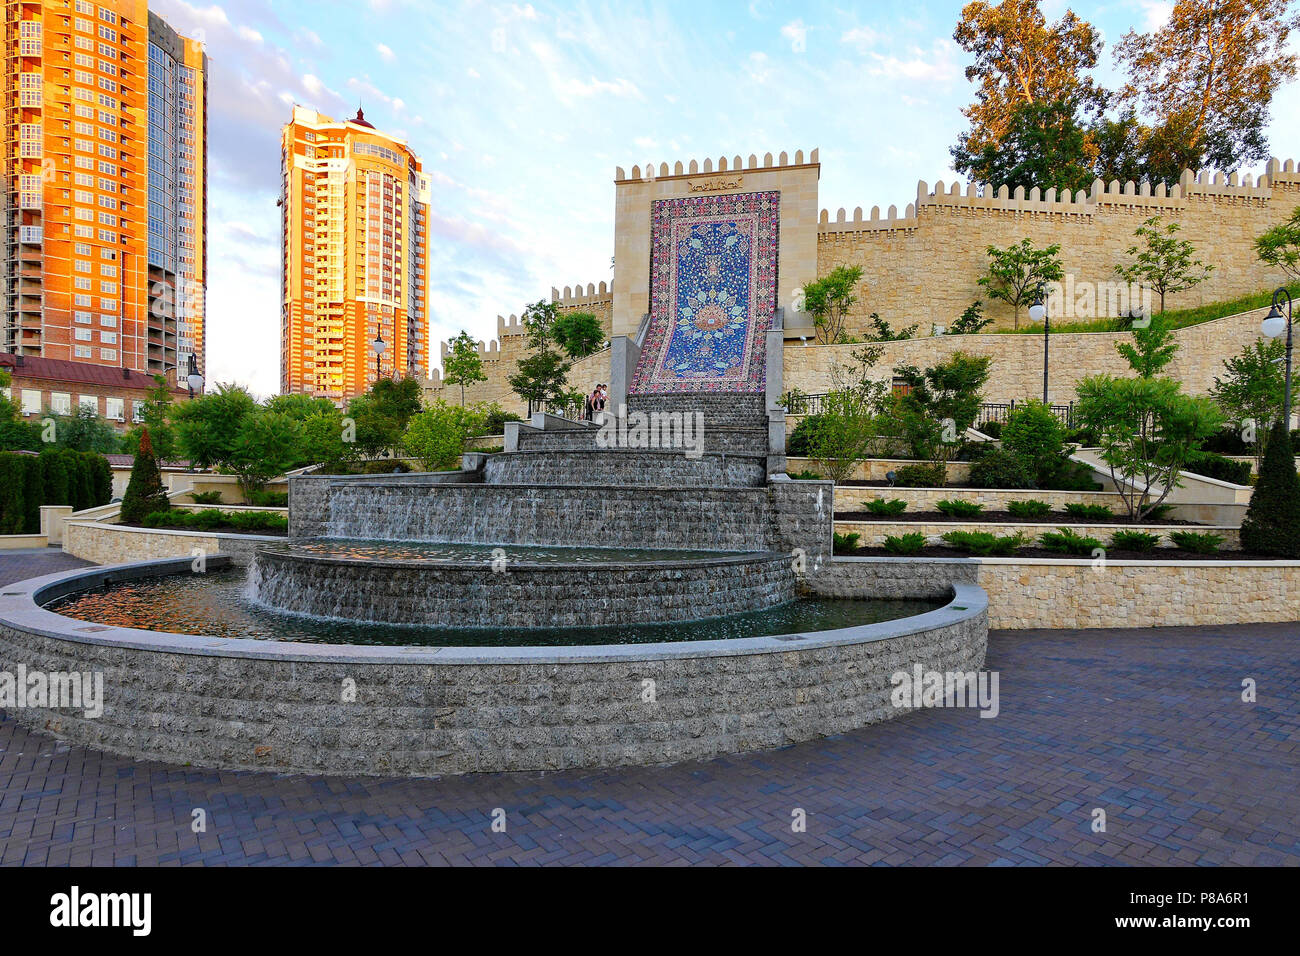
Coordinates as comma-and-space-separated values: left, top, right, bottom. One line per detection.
816, 166, 1300, 334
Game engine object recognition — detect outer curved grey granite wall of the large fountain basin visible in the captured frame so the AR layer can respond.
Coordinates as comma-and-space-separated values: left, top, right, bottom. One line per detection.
0, 561, 987, 775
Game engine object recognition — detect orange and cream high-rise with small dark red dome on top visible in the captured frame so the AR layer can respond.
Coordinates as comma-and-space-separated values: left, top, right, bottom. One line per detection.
281, 107, 429, 405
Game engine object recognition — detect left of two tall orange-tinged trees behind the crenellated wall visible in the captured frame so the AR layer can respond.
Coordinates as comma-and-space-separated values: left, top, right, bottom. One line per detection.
952, 0, 1105, 175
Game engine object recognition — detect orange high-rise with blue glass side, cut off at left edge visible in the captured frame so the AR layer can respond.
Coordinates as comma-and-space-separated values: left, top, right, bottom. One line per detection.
0, 0, 207, 381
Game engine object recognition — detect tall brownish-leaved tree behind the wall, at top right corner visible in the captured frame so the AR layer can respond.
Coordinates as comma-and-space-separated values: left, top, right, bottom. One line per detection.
1115, 0, 1300, 177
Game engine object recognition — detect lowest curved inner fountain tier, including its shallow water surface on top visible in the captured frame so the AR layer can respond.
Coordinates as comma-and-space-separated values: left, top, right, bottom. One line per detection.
248, 538, 796, 628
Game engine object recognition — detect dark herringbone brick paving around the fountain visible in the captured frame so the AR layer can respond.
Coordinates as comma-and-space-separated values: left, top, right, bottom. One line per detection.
0, 553, 1300, 866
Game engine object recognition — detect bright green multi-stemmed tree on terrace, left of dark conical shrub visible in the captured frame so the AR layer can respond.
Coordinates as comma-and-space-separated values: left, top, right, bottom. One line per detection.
1075, 375, 1223, 522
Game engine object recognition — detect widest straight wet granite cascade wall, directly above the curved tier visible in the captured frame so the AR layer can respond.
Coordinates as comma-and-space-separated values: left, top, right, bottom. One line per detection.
321, 481, 772, 551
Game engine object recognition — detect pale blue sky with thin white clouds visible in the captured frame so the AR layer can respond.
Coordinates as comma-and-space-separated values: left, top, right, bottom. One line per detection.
151, 0, 1300, 395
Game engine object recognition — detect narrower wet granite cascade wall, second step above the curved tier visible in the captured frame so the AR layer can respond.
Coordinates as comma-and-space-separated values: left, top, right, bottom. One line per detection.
485, 449, 767, 488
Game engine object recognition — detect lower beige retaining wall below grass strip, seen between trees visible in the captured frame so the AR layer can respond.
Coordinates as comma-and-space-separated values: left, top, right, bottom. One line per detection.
785, 303, 1268, 405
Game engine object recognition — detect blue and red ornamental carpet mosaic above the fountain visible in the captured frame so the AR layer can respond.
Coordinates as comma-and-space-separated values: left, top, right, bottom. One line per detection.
631, 191, 781, 394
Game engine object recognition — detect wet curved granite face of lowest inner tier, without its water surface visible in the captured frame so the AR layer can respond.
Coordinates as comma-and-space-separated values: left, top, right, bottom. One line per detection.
250, 551, 794, 627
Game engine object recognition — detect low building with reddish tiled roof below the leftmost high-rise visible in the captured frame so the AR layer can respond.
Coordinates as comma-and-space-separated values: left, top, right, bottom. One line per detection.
0, 352, 190, 431
